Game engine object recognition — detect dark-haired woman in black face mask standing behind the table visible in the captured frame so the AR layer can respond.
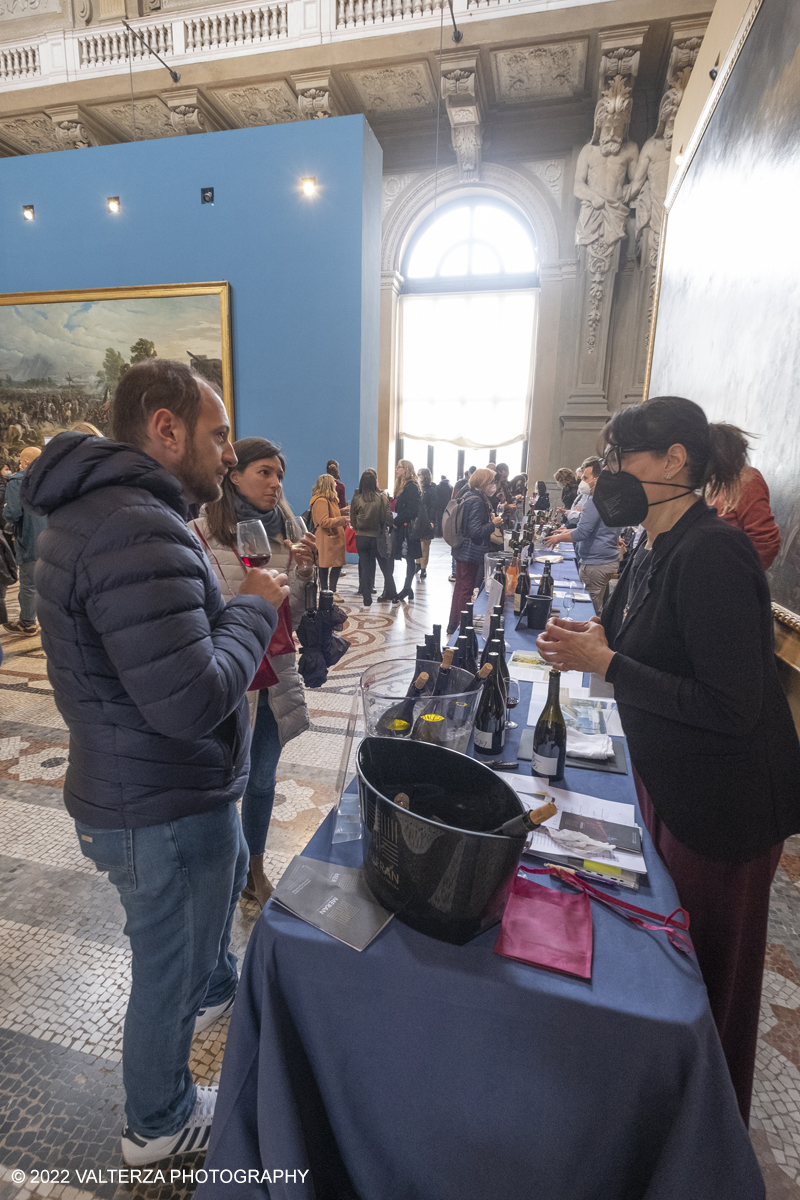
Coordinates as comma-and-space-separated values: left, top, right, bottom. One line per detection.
539, 396, 800, 1122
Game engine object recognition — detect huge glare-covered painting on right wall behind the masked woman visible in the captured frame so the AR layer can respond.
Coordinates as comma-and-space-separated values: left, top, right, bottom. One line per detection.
650, 0, 800, 612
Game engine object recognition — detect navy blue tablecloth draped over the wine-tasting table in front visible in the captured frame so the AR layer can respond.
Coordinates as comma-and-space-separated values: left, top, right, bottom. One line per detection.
197, 549, 764, 1200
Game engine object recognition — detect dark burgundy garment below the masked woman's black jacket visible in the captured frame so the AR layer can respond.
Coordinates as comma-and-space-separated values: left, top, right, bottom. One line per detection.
633, 770, 783, 1124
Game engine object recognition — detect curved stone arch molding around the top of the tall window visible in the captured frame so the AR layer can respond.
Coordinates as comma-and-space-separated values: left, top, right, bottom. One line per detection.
380, 162, 559, 272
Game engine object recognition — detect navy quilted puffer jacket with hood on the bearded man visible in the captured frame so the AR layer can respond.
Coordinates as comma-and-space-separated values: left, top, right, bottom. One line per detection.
23, 433, 277, 829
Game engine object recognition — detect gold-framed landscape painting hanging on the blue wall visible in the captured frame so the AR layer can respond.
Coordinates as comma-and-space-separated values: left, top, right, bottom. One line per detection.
0, 283, 234, 469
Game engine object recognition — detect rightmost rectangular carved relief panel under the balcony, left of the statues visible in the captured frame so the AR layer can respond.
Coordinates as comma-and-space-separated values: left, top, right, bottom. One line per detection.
492, 40, 587, 104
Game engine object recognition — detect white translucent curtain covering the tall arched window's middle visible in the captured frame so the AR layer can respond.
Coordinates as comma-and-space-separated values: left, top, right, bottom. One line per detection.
399, 290, 537, 450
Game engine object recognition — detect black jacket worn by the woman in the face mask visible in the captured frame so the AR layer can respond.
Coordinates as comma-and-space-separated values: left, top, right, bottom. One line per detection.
602, 500, 800, 862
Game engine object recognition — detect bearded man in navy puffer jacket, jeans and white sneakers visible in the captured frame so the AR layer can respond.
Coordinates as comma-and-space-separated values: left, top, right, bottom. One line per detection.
23, 359, 289, 1165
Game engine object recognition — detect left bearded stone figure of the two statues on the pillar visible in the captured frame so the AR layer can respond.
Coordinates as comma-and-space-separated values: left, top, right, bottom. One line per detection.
575, 76, 639, 354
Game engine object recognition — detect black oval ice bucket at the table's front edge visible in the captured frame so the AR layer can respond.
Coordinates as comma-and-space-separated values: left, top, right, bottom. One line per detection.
356, 738, 525, 946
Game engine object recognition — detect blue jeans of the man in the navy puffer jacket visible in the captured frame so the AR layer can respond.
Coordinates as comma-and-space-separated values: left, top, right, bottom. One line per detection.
76, 804, 247, 1138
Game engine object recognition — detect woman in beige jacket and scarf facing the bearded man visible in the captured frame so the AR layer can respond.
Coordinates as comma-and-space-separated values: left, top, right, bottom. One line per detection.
191, 438, 315, 907
